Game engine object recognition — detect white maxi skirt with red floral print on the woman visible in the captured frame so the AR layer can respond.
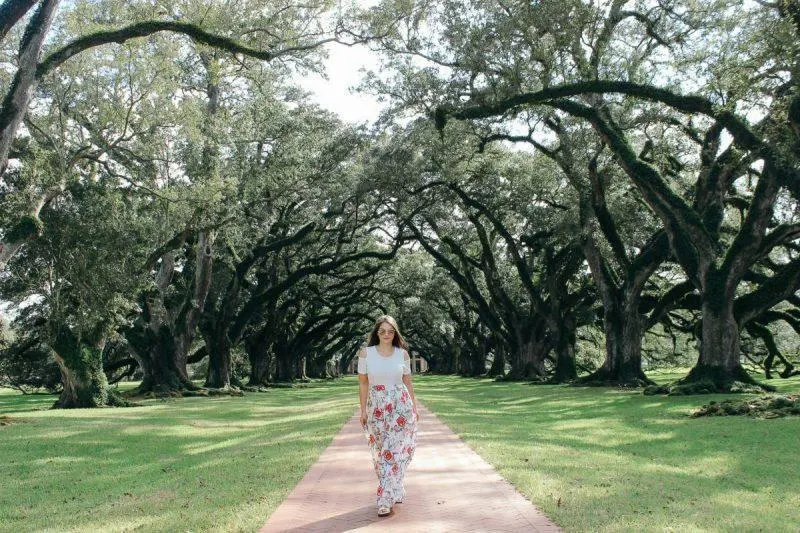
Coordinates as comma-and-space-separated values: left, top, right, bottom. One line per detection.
365, 383, 417, 507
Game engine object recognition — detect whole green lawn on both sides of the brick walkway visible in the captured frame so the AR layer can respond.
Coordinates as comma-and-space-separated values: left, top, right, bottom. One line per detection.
0, 374, 800, 532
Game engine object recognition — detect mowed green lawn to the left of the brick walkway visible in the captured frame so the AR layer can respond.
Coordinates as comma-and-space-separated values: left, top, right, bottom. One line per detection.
0, 381, 356, 532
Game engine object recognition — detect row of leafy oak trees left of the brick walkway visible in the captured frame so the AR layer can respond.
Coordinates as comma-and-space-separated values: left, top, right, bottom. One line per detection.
2, 1, 412, 407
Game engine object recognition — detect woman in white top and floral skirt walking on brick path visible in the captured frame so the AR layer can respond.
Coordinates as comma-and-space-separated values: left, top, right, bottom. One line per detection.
358, 315, 419, 516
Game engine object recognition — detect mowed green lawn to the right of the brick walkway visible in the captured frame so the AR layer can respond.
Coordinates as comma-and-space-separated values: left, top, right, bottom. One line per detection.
410, 373, 800, 533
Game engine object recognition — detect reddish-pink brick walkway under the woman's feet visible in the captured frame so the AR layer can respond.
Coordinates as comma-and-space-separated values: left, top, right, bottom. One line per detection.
261, 406, 561, 533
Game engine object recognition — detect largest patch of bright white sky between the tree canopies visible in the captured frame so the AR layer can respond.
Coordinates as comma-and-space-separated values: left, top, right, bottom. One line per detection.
298, 43, 381, 124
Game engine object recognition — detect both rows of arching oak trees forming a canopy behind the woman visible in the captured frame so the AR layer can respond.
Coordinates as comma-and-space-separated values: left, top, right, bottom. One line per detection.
0, 0, 800, 407
